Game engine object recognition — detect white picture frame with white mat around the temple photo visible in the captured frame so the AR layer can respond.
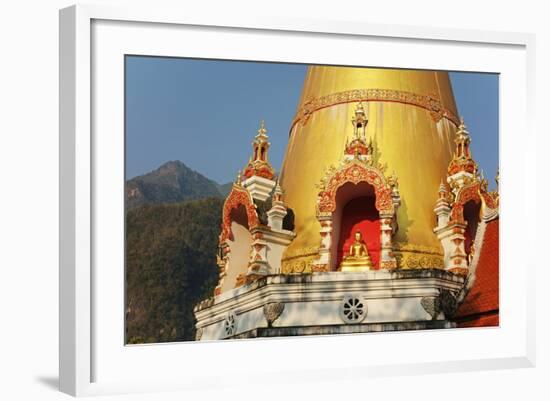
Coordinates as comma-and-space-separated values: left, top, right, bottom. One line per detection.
59, 5, 536, 396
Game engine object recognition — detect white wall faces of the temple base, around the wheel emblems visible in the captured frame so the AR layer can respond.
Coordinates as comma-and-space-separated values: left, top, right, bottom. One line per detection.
196, 271, 464, 340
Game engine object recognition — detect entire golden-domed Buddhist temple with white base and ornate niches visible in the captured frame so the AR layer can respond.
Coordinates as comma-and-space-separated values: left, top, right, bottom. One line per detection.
195, 66, 499, 340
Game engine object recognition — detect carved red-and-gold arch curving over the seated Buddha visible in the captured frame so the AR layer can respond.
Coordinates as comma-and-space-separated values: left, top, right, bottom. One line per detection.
319, 163, 393, 213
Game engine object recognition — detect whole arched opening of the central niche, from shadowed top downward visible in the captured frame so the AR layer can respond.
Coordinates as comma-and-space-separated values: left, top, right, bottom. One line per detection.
330, 182, 380, 270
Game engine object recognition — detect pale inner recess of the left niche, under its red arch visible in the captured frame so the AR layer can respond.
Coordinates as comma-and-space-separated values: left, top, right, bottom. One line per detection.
221, 205, 252, 293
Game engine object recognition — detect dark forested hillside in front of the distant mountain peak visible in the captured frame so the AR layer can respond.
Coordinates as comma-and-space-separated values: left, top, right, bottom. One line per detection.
126, 198, 223, 344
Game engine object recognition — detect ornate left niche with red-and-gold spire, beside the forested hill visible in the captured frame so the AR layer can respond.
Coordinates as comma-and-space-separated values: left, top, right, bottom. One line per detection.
215, 127, 295, 295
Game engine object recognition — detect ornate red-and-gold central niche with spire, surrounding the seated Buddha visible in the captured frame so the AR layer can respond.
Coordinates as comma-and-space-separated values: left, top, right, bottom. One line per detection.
313, 103, 401, 271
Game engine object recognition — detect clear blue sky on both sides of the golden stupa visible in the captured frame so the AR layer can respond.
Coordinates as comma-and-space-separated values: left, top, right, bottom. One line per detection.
126, 56, 498, 187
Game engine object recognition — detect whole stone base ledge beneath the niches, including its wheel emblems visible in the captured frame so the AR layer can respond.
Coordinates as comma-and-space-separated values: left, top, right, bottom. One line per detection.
195, 269, 465, 340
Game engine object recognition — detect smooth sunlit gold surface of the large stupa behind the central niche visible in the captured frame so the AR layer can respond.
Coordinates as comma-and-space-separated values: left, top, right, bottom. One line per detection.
281, 66, 458, 267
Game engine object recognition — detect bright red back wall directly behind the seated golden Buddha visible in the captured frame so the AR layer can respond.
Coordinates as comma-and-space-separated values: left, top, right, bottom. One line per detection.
336, 196, 380, 270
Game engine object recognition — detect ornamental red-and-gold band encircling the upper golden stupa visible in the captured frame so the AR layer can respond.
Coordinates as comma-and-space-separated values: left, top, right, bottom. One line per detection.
292, 89, 460, 128
